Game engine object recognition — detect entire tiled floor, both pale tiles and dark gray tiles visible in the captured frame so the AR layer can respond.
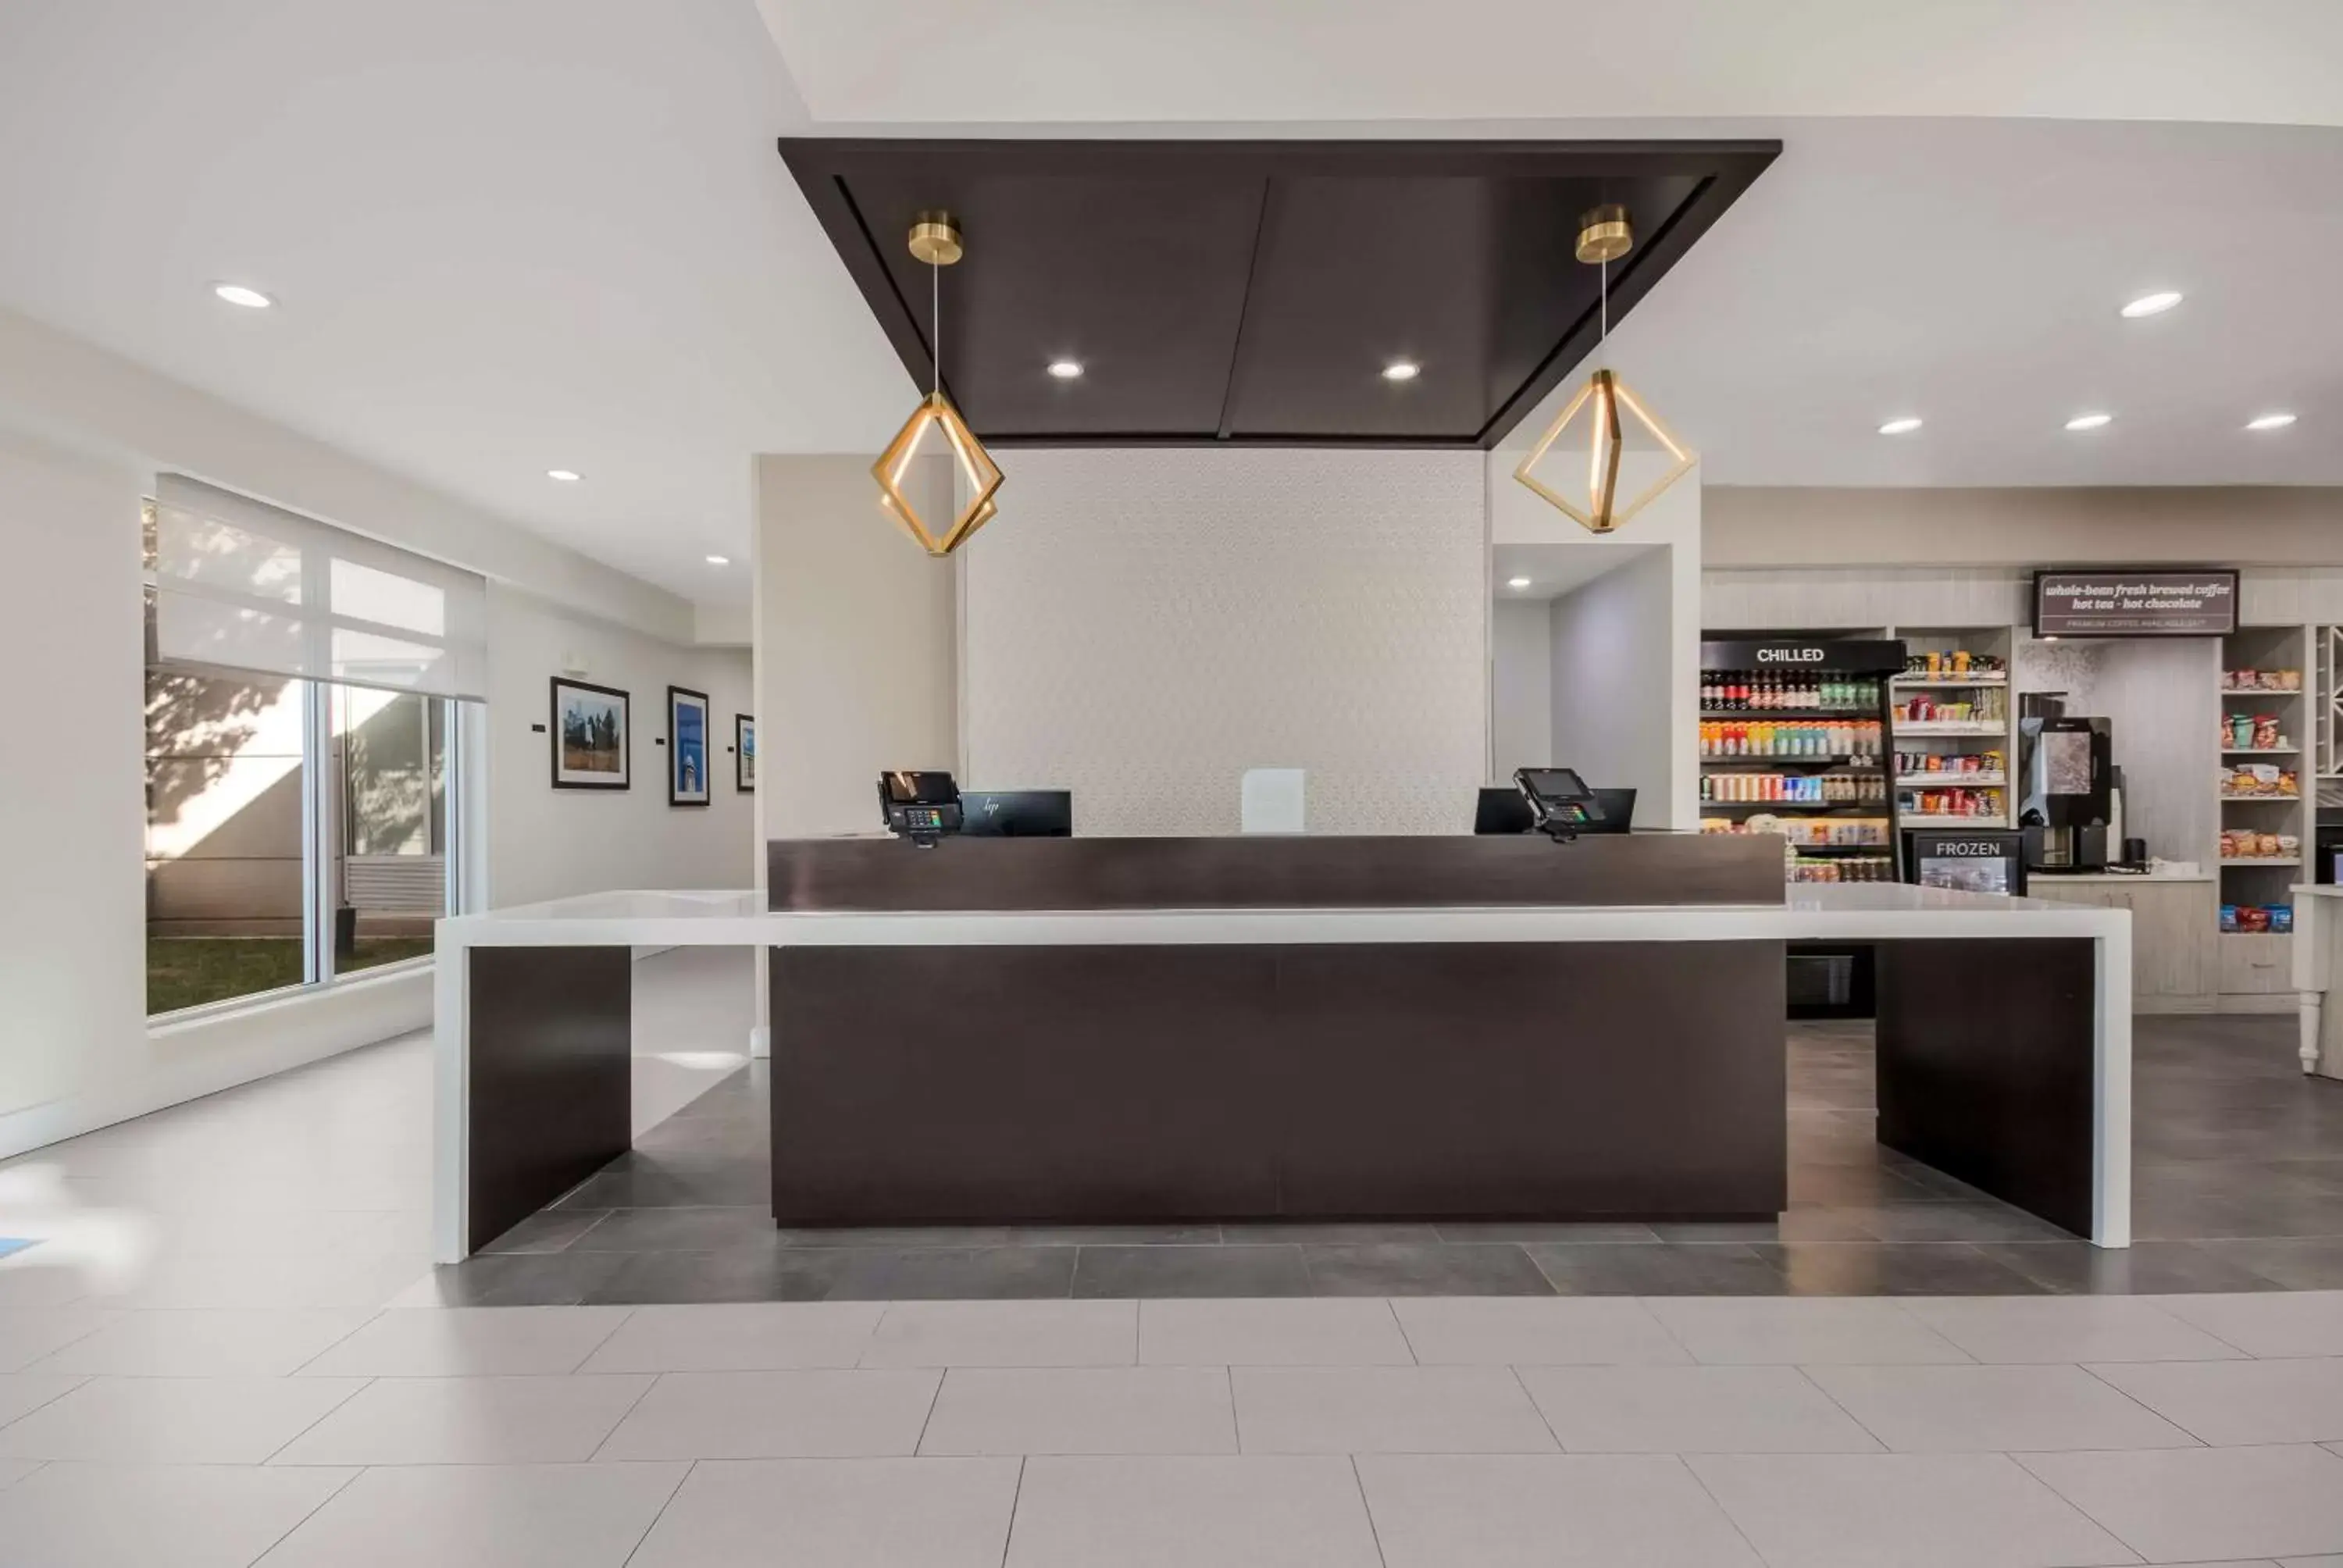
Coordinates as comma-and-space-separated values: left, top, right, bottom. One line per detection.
0, 954, 2343, 1568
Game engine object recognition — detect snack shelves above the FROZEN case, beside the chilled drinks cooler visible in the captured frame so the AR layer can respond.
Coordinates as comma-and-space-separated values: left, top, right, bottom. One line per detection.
1891, 625, 2017, 828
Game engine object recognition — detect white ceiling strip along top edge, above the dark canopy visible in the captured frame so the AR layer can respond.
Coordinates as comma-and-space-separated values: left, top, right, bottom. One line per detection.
759, 0, 2343, 136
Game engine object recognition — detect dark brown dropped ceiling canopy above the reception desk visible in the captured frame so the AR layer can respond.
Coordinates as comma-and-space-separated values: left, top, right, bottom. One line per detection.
780, 138, 1781, 447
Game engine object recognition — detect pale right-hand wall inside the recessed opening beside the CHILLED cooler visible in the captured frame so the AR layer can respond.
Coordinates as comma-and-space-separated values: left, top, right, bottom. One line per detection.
1553, 548, 1699, 828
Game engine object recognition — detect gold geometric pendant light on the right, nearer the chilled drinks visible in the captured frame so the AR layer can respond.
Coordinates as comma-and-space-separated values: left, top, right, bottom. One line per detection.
1514, 206, 1699, 534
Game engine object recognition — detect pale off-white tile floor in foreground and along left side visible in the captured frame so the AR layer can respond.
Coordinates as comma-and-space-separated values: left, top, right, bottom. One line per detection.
0, 954, 2343, 1568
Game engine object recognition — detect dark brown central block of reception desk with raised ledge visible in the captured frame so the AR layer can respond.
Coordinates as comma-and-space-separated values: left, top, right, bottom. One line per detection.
769, 835, 1785, 1226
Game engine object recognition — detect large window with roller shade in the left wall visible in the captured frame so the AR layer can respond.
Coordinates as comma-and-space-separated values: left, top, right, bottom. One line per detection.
145, 501, 471, 1015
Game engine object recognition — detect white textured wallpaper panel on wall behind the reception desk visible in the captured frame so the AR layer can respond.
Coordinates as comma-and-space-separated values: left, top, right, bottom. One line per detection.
963, 450, 1488, 835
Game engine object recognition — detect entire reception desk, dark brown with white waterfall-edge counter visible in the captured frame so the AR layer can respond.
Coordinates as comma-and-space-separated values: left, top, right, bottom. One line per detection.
438, 835, 2130, 1261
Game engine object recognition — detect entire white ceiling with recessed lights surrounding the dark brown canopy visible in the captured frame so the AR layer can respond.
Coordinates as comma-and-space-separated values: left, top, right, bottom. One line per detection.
0, 0, 2343, 604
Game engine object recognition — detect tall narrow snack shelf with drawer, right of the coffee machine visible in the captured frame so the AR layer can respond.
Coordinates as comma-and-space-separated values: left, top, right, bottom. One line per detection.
2214, 625, 2331, 1010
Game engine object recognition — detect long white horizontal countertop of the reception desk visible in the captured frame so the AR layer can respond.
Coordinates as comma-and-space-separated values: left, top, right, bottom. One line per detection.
436, 879, 2144, 947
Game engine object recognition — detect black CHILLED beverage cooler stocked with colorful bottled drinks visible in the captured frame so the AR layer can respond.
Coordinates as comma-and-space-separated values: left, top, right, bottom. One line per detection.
1701, 633, 1905, 1017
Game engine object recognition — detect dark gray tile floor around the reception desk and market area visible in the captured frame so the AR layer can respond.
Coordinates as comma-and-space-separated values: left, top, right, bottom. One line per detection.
431, 1017, 2343, 1306
